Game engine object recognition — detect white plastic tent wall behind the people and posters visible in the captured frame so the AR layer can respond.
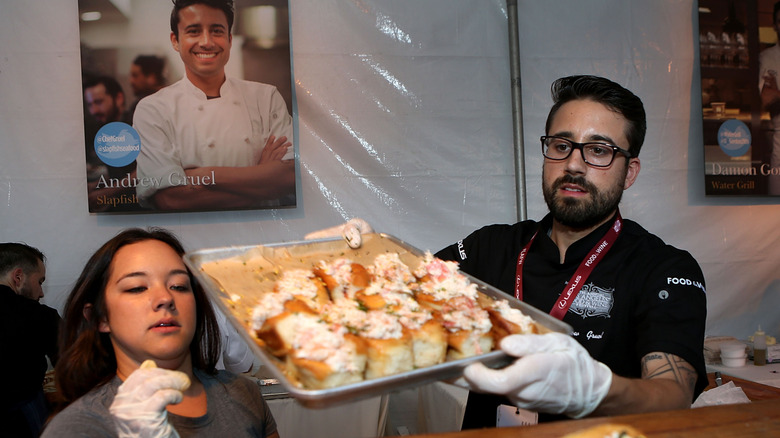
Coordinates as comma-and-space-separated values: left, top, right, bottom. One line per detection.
0, 0, 780, 350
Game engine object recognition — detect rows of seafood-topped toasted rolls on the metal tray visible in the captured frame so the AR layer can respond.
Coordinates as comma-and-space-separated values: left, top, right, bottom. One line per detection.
244, 252, 539, 389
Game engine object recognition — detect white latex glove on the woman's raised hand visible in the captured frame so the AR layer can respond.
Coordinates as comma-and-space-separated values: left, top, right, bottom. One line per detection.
109, 360, 190, 438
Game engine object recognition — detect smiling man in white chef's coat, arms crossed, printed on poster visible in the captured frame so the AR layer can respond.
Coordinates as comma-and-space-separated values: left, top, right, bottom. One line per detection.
133, 0, 295, 210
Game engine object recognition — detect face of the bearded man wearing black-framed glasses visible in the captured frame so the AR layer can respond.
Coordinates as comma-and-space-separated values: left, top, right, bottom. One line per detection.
542, 100, 639, 229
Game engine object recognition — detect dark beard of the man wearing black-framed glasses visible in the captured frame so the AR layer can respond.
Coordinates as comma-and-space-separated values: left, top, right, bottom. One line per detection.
542, 174, 625, 230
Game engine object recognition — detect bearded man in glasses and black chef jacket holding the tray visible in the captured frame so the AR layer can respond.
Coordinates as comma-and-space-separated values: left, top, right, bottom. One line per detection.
436, 76, 707, 428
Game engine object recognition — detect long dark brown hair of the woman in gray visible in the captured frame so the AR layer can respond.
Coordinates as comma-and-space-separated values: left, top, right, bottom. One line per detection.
55, 228, 220, 402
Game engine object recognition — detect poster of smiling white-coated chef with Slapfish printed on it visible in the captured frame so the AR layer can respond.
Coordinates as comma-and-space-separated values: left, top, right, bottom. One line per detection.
79, 0, 299, 213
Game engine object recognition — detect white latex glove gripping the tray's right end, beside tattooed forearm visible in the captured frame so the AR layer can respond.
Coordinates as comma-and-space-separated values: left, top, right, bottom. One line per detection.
464, 333, 612, 418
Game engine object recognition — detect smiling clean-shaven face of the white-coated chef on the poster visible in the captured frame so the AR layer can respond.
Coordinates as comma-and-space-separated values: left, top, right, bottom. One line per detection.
171, 4, 233, 84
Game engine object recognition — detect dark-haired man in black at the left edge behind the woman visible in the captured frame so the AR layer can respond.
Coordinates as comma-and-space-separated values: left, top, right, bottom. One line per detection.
0, 243, 61, 437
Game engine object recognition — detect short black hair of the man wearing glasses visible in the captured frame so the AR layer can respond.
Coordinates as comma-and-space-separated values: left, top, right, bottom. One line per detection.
544, 76, 647, 157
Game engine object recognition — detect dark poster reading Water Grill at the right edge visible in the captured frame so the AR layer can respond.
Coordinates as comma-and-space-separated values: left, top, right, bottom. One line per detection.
699, 0, 780, 196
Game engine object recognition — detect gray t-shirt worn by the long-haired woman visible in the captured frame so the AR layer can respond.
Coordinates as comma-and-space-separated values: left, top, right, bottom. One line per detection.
41, 371, 276, 438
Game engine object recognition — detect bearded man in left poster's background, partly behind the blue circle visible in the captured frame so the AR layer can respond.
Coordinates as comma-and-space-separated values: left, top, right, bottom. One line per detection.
82, 76, 139, 212
